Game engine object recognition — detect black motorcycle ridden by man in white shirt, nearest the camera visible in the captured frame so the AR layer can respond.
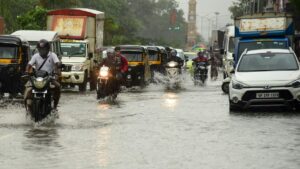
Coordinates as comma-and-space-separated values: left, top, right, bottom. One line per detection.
23, 70, 55, 122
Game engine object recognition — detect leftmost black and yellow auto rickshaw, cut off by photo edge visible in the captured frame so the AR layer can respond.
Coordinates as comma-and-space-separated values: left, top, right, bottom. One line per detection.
0, 35, 30, 97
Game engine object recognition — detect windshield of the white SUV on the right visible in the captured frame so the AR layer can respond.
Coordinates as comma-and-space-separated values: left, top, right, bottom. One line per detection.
238, 53, 299, 72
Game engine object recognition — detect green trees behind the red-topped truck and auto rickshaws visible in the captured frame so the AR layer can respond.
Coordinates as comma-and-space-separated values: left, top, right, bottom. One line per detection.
0, 0, 187, 47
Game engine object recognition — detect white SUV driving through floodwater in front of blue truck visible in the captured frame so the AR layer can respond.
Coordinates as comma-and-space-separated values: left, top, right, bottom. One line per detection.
229, 49, 300, 111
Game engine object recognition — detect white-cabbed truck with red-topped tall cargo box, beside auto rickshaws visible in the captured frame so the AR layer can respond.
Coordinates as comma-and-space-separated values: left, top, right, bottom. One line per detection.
47, 8, 105, 91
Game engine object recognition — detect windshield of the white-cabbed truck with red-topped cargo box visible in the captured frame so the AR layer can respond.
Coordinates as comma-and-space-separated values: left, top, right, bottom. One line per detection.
61, 43, 86, 57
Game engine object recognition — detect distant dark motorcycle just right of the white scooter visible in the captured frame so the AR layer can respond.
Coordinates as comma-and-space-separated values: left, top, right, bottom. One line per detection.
194, 62, 208, 85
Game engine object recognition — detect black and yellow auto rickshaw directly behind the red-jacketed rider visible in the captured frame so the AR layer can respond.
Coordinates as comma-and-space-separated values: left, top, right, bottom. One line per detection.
119, 45, 151, 87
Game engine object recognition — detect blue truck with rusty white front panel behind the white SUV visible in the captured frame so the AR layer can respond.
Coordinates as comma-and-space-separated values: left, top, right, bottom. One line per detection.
234, 12, 295, 66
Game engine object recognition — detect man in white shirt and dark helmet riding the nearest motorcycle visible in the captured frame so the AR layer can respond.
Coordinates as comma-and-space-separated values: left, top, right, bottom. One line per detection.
24, 39, 61, 110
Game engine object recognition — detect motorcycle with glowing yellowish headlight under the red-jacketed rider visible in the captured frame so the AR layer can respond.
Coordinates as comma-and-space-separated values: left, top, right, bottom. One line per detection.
96, 66, 119, 100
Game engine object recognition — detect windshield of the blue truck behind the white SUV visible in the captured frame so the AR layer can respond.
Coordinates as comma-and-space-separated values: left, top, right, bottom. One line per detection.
238, 41, 288, 58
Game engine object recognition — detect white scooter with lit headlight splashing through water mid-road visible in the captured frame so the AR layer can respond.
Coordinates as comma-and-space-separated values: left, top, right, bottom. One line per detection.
165, 61, 181, 88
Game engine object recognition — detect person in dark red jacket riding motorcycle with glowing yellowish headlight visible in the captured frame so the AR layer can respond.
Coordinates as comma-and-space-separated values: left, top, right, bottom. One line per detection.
99, 47, 128, 88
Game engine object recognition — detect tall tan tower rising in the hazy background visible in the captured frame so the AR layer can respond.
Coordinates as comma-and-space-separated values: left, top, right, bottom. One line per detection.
186, 0, 198, 49
